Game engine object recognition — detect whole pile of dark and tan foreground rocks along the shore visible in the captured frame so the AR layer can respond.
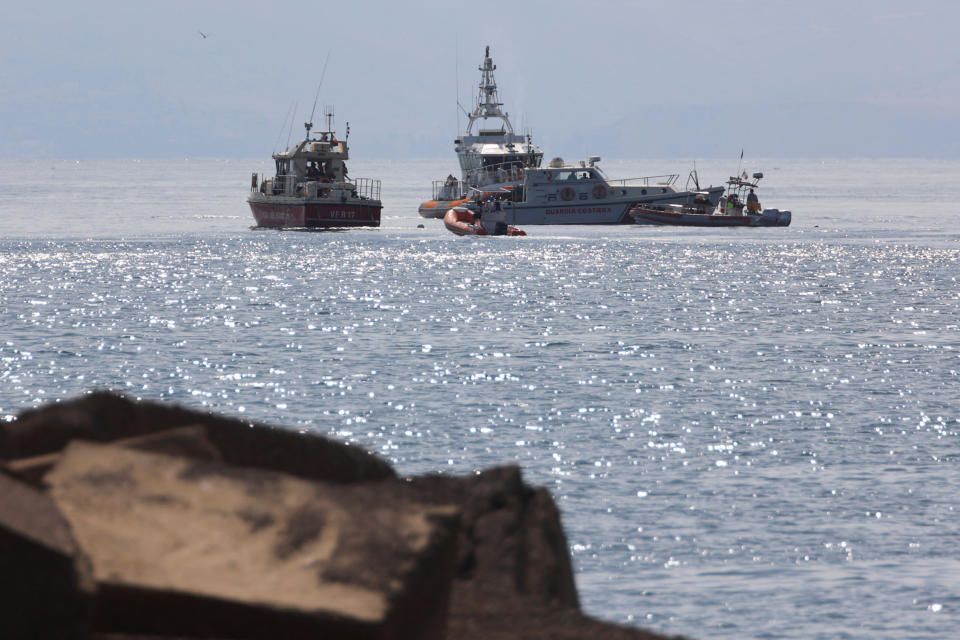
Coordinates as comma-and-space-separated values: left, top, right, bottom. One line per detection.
0, 393, 688, 640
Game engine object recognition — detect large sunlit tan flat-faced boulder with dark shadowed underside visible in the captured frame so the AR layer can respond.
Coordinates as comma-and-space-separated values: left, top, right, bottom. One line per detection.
45, 442, 456, 639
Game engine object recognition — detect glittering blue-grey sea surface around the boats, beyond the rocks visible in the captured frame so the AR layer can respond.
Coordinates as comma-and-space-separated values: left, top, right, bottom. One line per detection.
0, 157, 960, 640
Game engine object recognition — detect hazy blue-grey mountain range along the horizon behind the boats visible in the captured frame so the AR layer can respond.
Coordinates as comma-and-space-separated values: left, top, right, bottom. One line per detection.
0, 97, 960, 160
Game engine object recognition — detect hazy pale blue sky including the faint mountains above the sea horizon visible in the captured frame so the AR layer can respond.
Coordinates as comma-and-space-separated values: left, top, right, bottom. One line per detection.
0, 0, 960, 159
